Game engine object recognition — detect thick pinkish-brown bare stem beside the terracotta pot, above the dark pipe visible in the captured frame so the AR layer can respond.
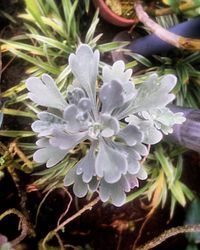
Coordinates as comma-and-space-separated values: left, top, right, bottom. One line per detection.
134, 1, 200, 51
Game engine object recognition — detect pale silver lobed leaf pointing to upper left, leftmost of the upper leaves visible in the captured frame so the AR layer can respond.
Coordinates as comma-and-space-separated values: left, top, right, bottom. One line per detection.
26, 74, 67, 109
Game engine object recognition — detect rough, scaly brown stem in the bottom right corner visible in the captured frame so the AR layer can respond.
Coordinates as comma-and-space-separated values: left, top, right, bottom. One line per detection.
135, 224, 200, 250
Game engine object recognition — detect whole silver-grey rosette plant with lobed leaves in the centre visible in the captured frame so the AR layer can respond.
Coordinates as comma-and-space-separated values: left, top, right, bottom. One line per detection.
27, 44, 185, 206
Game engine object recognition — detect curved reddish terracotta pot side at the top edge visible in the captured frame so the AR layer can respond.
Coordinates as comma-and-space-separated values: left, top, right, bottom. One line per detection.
93, 0, 137, 27
